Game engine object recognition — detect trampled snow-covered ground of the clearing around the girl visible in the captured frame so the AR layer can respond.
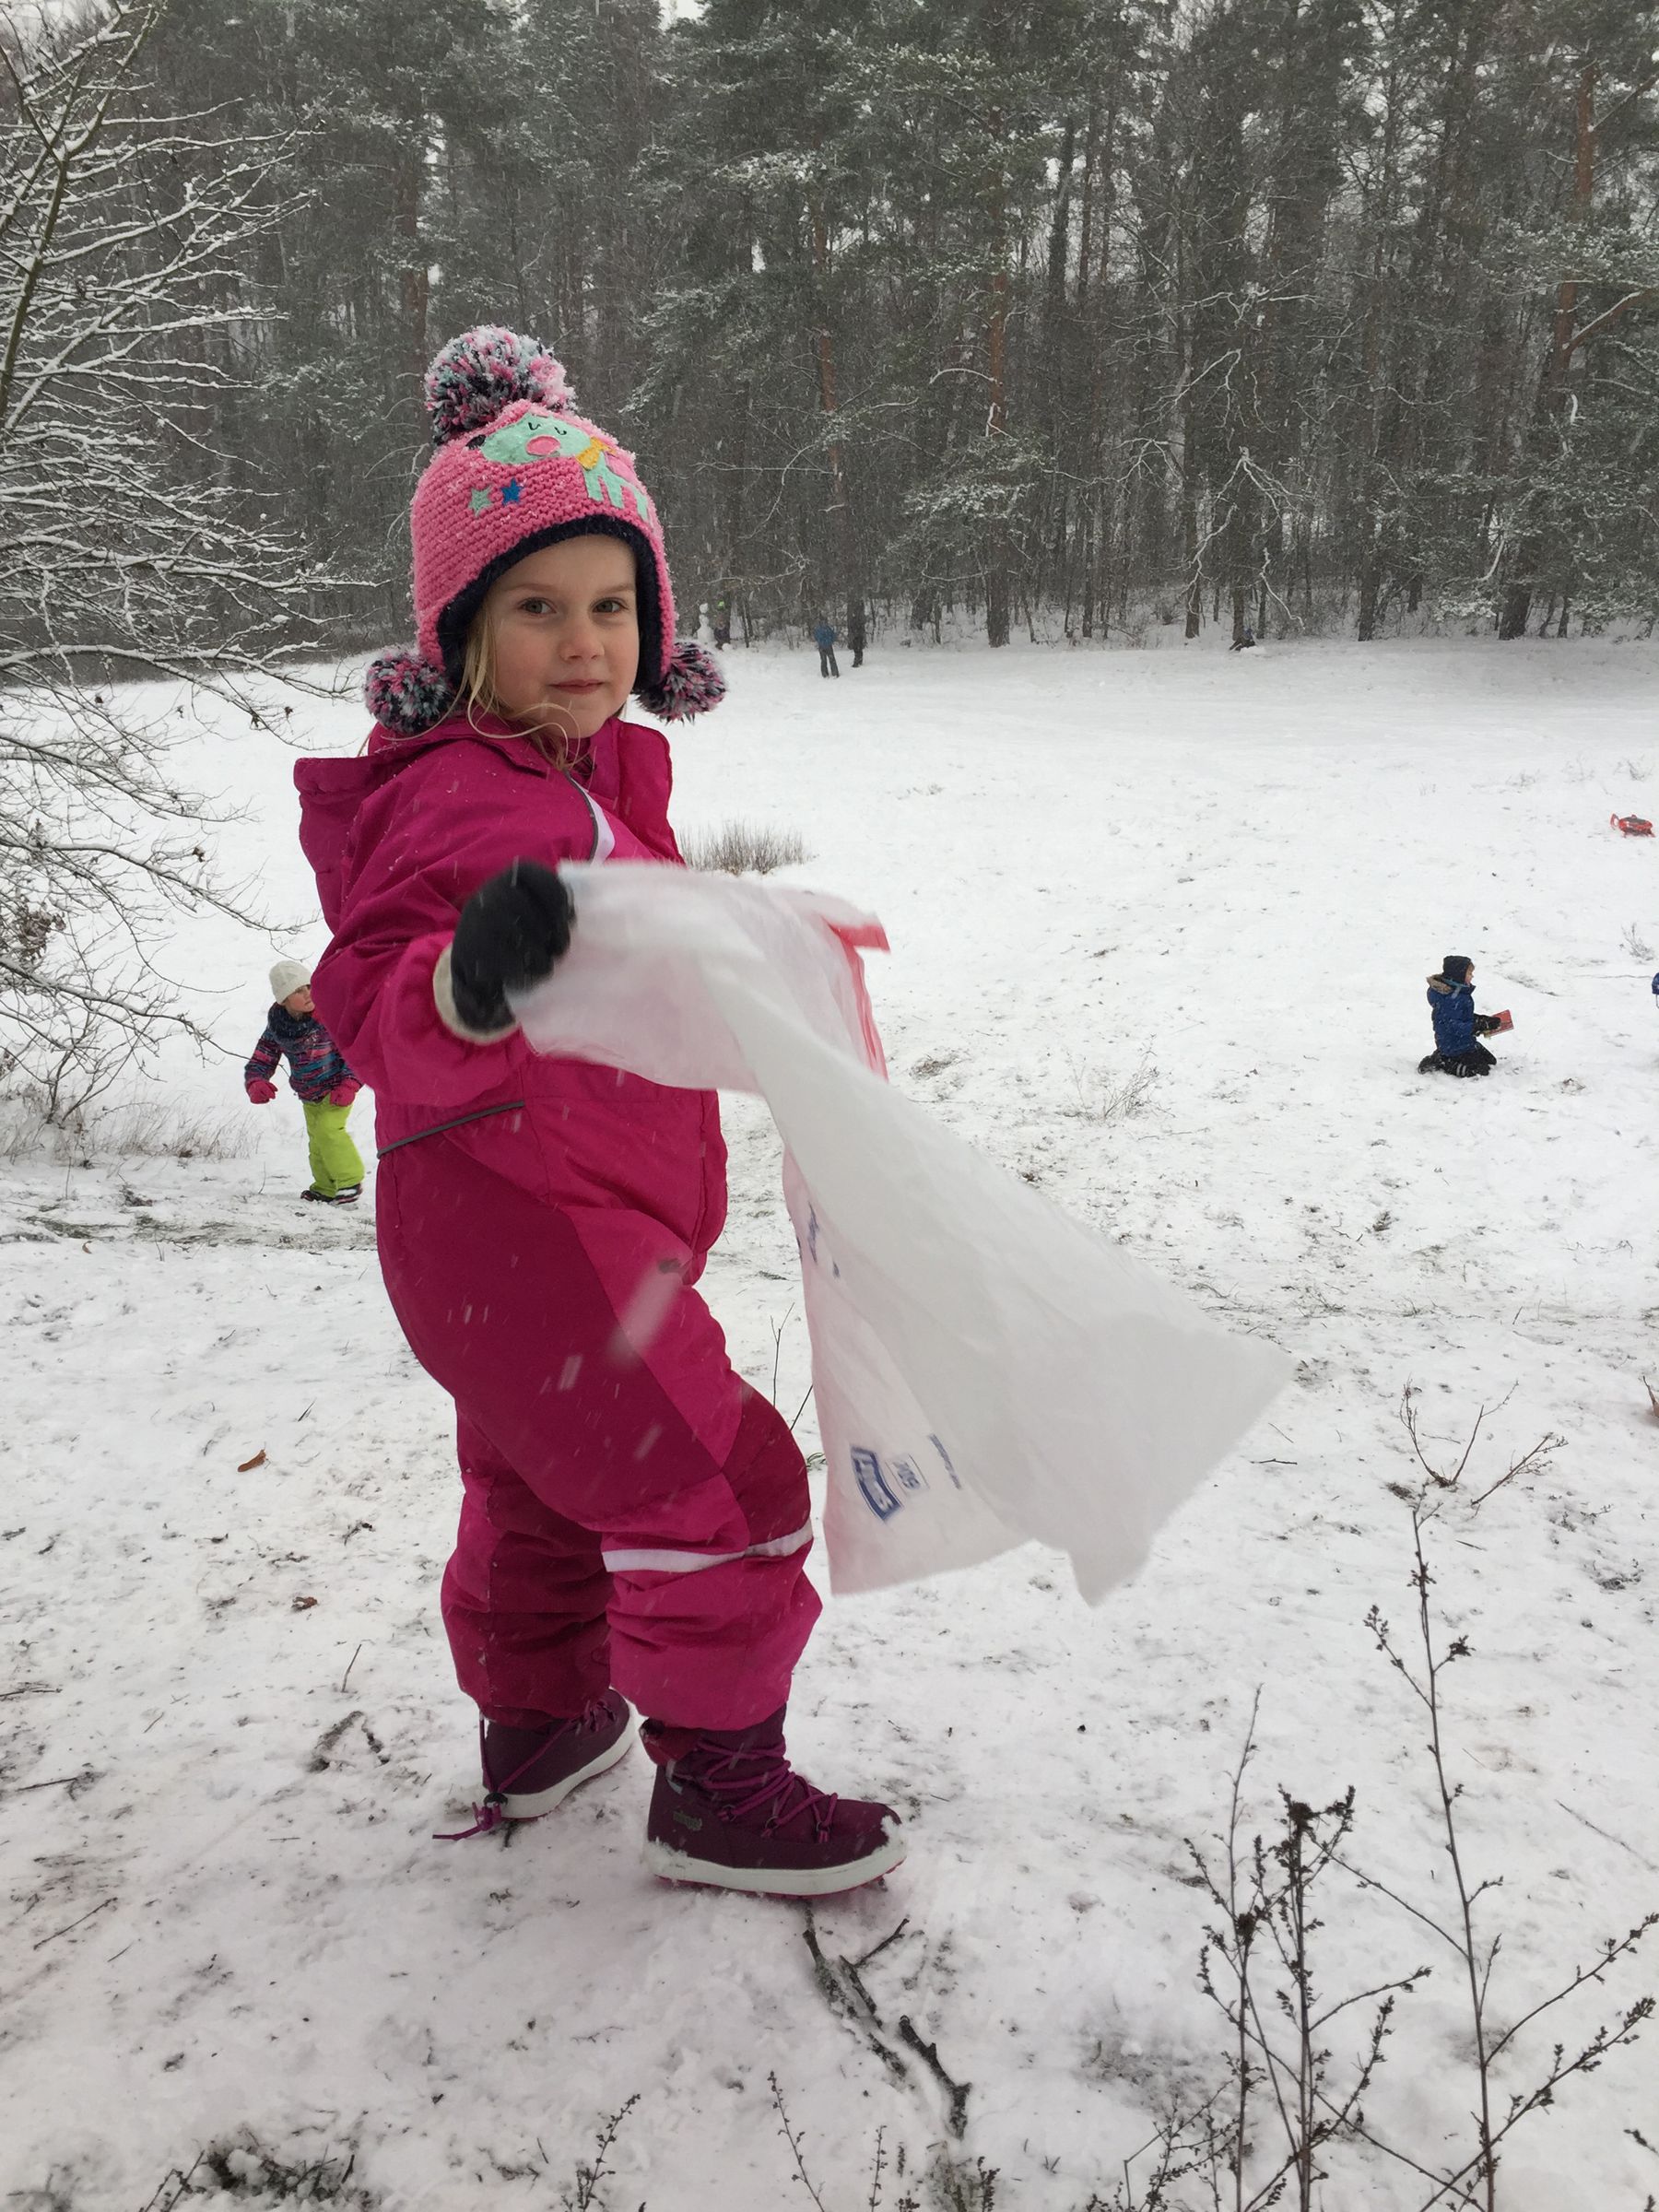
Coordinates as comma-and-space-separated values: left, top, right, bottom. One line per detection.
0, 643, 1659, 2212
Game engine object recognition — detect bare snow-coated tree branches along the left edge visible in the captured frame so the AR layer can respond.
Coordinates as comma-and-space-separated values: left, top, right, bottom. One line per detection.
0, 0, 334, 1119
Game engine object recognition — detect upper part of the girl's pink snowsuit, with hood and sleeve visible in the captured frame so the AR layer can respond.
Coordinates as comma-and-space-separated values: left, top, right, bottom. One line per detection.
294, 717, 725, 1261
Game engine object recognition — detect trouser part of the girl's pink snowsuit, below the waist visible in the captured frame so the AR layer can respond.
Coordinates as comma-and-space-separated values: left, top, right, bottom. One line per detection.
376, 1137, 818, 1727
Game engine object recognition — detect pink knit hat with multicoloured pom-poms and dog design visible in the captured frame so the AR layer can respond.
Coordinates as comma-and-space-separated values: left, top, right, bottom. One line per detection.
363, 323, 725, 736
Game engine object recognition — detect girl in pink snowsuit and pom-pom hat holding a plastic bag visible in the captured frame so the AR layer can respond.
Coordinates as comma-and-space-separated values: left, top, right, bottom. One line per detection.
297, 327, 902, 1896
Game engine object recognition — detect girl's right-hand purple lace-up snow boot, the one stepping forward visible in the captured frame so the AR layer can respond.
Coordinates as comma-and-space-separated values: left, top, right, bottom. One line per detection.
640, 1705, 905, 1898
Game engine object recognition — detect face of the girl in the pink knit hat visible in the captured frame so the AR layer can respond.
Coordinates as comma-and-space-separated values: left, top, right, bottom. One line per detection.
482, 535, 640, 741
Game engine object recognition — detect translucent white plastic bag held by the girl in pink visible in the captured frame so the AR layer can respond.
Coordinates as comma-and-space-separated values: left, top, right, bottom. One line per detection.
513, 863, 1289, 1604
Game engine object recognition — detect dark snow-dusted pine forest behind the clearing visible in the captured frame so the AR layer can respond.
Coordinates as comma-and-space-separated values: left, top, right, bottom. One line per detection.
32, 0, 1659, 643
